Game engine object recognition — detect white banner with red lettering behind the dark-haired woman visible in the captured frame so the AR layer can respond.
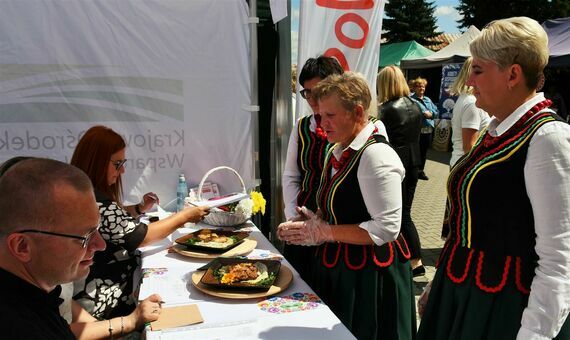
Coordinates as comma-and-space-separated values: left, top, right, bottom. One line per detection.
296, 0, 384, 118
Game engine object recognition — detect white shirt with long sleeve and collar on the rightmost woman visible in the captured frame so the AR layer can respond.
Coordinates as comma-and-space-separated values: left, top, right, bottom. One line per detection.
488, 93, 570, 340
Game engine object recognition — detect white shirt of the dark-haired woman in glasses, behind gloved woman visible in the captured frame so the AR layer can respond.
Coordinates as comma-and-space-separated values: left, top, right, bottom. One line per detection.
282, 115, 388, 220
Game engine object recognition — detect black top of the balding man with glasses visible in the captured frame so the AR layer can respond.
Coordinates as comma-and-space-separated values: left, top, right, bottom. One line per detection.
0, 268, 75, 340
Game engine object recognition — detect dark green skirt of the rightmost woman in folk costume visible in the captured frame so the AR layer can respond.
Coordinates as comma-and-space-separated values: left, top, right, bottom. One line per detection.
418, 265, 570, 340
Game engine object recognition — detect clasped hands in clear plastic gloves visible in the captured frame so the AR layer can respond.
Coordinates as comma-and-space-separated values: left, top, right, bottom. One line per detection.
277, 207, 334, 246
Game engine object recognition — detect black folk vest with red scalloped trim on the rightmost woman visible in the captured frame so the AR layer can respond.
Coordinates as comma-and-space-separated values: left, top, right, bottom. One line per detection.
438, 111, 556, 294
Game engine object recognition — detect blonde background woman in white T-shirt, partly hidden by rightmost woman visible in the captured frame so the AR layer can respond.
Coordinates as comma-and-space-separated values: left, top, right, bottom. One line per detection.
449, 57, 491, 167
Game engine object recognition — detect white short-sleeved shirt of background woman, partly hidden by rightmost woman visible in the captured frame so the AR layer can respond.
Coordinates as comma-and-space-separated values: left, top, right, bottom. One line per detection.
449, 94, 491, 166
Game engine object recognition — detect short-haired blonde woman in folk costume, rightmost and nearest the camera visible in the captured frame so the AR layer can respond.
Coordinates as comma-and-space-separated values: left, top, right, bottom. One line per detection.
418, 17, 570, 340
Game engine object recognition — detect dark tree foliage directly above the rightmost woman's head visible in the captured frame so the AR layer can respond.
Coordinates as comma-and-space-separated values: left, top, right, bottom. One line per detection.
456, 0, 570, 28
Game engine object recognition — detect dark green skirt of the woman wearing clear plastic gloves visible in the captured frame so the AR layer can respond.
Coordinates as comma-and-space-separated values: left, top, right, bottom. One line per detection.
312, 246, 417, 340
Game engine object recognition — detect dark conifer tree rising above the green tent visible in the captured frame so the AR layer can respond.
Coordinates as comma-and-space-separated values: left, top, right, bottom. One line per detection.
382, 0, 440, 45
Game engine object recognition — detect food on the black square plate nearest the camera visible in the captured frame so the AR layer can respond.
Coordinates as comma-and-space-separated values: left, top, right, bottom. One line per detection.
214, 262, 275, 287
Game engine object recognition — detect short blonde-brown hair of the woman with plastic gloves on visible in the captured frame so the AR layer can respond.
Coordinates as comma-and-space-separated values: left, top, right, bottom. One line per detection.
311, 71, 372, 115
